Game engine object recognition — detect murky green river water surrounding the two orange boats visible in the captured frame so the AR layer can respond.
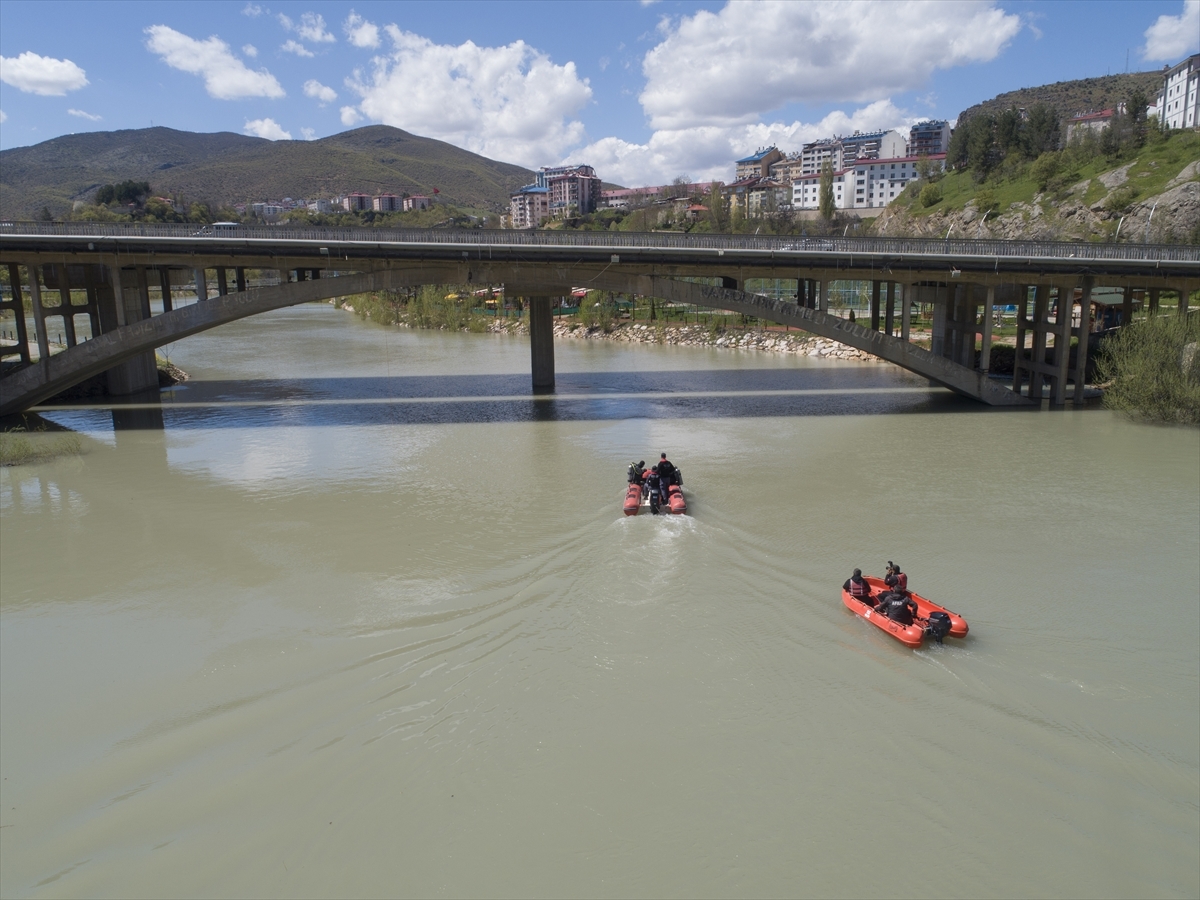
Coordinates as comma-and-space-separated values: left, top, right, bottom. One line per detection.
0, 306, 1200, 898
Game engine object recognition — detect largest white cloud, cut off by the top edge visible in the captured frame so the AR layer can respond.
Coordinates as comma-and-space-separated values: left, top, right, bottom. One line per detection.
640, 0, 1021, 128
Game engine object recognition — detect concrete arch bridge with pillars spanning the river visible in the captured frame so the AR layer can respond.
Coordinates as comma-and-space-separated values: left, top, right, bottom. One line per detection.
0, 223, 1200, 415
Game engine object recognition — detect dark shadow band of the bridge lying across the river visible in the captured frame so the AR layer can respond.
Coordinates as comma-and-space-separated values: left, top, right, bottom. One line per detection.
35, 366, 1003, 428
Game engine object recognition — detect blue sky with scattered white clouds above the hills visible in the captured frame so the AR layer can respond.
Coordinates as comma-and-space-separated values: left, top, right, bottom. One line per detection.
0, 0, 1200, 185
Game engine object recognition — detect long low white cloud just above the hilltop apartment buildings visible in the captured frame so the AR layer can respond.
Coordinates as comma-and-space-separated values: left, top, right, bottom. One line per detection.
565, 100, 902, 186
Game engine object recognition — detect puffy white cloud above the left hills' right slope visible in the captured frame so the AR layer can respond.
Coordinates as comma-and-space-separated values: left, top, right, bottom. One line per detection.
347, 25, 592, 166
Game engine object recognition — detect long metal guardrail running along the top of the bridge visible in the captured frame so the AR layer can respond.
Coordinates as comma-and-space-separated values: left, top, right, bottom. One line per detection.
0, 222, 1200, 263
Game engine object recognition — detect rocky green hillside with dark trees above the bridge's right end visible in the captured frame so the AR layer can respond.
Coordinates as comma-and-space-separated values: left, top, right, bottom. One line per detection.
875, 89, 1200, 244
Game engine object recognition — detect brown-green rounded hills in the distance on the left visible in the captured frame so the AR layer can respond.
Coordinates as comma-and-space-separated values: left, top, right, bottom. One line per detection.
0, 125, 533, 218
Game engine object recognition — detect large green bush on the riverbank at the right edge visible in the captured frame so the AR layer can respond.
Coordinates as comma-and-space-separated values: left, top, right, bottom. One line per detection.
1097, 313, 1200, 425
